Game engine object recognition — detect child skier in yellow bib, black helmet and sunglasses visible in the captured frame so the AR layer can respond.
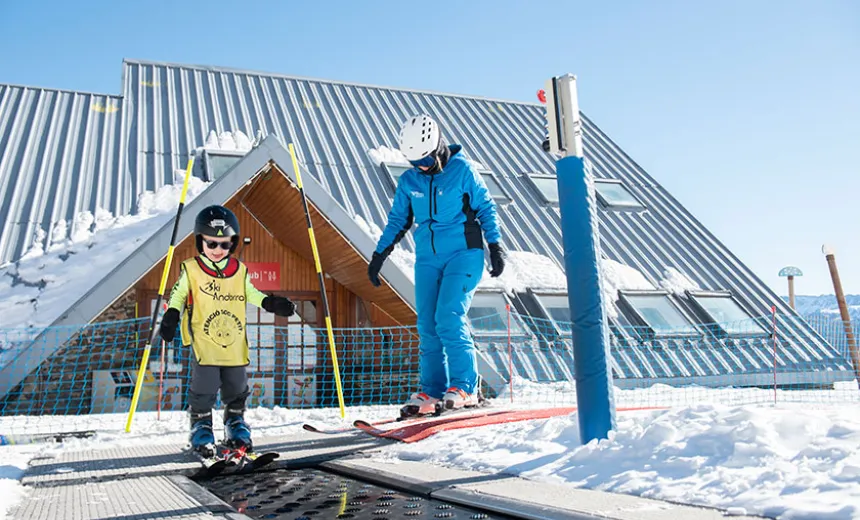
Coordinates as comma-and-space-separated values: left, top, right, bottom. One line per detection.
159, 206, 295, 458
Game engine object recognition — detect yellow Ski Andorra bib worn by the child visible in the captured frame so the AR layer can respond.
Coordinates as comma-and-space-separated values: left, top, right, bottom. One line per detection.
182, 258, 249, 367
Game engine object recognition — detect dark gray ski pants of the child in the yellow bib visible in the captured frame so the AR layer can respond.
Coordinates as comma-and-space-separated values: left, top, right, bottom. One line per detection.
188, 354, 251, 414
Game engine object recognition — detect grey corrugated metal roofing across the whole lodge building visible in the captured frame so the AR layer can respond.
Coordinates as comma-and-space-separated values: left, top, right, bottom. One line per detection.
0, 60, 850, 388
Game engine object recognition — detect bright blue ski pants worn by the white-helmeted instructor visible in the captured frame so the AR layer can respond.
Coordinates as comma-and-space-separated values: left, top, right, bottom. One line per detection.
415, 249, 484, 399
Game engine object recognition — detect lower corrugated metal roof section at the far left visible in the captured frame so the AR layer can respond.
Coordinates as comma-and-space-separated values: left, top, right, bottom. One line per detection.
0, 85, 126, 264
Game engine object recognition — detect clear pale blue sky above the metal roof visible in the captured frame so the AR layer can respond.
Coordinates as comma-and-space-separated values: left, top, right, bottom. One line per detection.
0, 0, 860, 294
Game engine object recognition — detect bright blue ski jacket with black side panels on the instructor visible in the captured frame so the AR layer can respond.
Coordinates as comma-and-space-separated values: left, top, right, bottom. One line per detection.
376, 144, 501, 259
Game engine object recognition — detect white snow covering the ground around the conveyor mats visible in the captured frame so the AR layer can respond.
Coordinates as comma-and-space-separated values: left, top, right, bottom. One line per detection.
0, 381, 860, 520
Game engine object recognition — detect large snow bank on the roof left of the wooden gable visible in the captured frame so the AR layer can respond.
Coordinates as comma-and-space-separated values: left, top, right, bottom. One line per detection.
0, 170, 208, 334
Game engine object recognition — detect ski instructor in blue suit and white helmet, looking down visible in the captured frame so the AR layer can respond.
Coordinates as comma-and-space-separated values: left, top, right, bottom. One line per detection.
367, 114, 505, 415
